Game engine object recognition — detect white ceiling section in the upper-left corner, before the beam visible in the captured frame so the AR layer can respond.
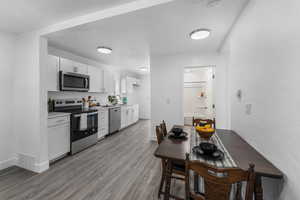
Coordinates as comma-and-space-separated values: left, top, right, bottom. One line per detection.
0, 0, 134, 33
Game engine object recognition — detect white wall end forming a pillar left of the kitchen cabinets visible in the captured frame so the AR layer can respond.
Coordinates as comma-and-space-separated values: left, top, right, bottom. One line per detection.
13, 33, 48, 172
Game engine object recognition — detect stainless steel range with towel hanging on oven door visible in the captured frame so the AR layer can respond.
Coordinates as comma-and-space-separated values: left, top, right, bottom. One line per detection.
53, 99, 98, 154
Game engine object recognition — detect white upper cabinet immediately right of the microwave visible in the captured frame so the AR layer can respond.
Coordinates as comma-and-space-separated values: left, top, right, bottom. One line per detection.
88, 66, 103, 92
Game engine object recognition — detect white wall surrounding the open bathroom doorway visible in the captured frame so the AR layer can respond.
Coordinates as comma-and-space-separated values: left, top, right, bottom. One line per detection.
150, 53, 229, 138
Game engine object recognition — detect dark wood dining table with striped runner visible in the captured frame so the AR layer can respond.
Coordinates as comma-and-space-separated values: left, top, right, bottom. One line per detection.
154, 125, 283, 200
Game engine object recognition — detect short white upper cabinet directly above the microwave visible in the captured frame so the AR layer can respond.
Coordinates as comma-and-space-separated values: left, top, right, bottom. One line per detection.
60, 58, 88, 74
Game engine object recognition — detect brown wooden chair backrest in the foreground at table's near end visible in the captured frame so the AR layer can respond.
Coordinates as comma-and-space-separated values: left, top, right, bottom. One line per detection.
185, 154, 255, 200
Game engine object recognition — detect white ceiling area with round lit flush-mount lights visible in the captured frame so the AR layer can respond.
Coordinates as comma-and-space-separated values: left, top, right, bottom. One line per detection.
48, 0, 248, 70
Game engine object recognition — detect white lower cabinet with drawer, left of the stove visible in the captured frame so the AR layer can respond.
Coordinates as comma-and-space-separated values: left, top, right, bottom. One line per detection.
48, 114, 70, 162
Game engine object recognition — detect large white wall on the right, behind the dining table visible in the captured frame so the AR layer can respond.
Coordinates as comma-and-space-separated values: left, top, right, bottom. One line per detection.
227, 0, 300, 200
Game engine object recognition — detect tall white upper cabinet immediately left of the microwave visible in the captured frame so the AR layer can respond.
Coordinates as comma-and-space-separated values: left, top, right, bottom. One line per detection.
46, 55, 59, 91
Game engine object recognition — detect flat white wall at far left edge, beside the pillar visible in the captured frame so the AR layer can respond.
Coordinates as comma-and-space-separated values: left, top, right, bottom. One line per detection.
0, 32, 16, 170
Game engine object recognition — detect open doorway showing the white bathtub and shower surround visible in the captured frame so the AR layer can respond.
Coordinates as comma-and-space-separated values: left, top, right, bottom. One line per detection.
183, 66, 215, 125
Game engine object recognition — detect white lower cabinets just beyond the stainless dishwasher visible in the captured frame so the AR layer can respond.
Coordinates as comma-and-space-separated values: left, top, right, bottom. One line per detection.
121, 104, 139, 129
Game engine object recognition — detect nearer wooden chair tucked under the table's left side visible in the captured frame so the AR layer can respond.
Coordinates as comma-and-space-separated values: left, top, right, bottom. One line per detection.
156, 126, 185, 200
